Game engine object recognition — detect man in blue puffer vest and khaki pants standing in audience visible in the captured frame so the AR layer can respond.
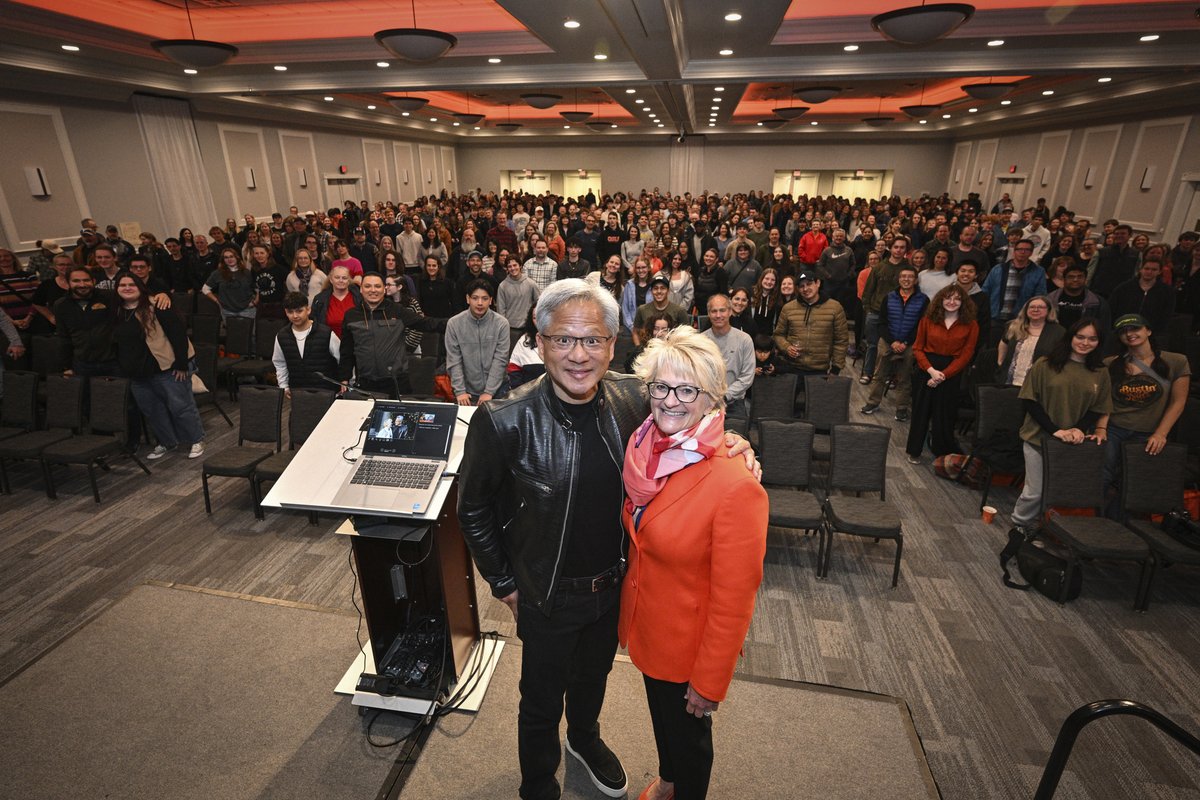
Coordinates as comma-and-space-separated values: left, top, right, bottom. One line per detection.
862, 266, 929, 422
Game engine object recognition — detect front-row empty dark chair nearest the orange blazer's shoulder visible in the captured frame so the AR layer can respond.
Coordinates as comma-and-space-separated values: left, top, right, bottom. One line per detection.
758, 420, 824, 556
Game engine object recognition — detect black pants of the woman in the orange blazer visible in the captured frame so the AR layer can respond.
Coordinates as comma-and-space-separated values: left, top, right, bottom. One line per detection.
642, 675, 713, 800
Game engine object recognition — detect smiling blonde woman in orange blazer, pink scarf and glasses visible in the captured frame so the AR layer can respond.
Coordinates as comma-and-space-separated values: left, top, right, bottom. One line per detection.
619, 327, 767, 800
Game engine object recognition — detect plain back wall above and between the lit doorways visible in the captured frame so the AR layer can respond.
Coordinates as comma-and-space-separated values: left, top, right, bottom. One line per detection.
458, 138, 952, 196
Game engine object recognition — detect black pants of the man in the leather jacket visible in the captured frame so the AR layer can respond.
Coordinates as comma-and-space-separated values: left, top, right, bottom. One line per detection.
517, 585, 620, 800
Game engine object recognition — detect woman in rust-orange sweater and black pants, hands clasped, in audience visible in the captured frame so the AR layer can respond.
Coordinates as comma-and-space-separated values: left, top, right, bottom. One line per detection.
905, 283, 979, 464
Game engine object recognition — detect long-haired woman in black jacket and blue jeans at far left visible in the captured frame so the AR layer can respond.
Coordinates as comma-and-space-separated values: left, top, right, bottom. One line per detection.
112, 272, 204, 459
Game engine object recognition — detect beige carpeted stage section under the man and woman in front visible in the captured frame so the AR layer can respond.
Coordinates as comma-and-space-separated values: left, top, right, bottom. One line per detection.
400, 642, 938, 800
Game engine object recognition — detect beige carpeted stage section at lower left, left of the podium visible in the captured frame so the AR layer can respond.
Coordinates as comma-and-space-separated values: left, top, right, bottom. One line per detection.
0, 585, 408, 800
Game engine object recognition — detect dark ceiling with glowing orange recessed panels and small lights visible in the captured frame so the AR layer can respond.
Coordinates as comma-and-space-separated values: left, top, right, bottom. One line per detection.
0, 0, 1200, 143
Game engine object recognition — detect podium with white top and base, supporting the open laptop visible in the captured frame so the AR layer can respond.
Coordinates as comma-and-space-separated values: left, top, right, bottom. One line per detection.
263, 399, 504, 714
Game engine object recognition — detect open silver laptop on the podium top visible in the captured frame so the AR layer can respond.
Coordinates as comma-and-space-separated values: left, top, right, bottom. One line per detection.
332, 401, 458, 516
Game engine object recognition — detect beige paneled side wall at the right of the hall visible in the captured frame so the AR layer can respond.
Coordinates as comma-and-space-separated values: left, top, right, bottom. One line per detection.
946, 115, 1200, 241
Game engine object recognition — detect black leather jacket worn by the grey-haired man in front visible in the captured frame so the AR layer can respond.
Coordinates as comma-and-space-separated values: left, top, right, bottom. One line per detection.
458, 372, 649, 616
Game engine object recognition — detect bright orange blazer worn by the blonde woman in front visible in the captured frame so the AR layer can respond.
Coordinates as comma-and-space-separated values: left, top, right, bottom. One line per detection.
618, 445, 768, 700
